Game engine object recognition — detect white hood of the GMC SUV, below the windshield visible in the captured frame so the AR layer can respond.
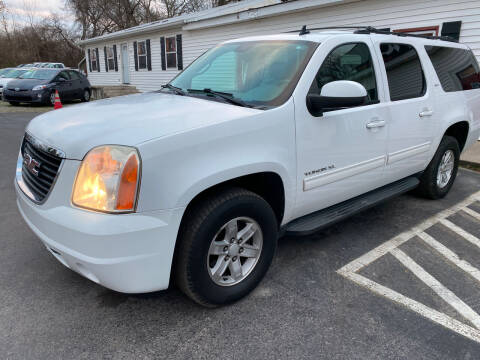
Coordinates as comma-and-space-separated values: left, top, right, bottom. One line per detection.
27, 93, 263, 160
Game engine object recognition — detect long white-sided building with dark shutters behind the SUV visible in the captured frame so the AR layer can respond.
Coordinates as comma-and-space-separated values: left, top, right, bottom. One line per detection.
82, 0, 480, 91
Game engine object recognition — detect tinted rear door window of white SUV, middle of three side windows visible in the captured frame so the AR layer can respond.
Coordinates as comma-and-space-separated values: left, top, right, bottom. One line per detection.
380, 43, 426, 101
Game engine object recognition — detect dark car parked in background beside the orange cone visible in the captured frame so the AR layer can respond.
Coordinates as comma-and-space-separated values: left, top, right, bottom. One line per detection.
3, 69, 91, 105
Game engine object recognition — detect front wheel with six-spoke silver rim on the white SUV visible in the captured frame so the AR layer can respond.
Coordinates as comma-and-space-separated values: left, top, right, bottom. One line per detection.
174, 188, 278, 307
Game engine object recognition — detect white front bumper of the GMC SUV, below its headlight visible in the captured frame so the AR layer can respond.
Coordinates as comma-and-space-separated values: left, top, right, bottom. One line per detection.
15, 160, 184, 293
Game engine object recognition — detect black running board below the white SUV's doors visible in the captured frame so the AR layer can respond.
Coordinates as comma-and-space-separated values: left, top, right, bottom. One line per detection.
282, 176, 420, 236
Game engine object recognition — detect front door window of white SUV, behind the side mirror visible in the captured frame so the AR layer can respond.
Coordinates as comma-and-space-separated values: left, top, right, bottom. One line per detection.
309, 43, 378, 103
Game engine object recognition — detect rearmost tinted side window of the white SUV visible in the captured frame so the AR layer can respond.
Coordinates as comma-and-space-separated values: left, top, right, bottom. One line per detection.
425, 46, 480, 92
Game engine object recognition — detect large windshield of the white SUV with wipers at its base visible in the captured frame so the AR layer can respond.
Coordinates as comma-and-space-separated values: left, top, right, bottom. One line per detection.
171, 40, 318, 106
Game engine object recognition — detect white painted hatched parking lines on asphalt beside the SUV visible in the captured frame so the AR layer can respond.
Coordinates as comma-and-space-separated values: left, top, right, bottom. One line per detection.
337, 191, 480, 343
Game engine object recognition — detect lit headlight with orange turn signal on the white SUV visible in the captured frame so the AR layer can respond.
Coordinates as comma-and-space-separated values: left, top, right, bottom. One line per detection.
72, 145, 141, 213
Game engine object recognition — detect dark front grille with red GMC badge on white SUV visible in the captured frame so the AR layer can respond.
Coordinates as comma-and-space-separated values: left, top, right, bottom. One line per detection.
21, 135, 62, 202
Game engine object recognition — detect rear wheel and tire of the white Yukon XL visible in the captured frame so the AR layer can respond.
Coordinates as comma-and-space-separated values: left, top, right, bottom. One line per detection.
416, 136, 460, 200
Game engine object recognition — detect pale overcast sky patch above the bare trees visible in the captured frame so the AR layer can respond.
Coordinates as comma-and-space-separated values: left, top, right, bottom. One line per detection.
5, 0, 73, 23
